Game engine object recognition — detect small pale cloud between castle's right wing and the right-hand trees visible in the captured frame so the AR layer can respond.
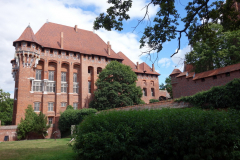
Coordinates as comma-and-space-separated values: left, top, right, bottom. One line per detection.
171, 46, 191, 71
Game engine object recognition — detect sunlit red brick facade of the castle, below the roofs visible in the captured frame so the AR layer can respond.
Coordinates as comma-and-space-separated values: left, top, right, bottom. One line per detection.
13, 42, 159, 128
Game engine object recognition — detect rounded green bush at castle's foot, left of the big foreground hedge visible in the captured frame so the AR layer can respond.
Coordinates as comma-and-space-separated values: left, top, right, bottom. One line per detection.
58, 108, 97, 133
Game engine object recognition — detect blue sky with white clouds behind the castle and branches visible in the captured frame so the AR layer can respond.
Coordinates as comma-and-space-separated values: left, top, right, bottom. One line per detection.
0, 0, 190, 98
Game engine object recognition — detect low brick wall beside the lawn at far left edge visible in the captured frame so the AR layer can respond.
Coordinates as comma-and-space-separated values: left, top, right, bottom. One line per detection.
0, 125, 17, 142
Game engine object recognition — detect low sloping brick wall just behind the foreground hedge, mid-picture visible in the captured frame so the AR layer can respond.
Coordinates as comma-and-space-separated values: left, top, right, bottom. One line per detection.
111, 100, 191, 110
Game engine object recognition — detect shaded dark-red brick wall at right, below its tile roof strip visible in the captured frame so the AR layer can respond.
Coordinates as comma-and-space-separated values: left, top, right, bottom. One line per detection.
171, 70, 240, 98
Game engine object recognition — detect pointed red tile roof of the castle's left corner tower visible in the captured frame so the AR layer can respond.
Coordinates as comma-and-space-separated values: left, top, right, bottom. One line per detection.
14, 26, 38, 43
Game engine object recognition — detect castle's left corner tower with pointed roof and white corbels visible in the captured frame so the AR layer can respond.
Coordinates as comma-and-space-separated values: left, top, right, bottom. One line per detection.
11, 26, 42, 125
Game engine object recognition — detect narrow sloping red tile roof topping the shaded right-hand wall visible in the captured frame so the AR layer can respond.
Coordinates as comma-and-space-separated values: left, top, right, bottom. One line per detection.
193, 63, 240, 80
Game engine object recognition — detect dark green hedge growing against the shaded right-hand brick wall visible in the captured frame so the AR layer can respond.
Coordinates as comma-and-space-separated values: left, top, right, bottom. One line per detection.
175, 79, 240, 109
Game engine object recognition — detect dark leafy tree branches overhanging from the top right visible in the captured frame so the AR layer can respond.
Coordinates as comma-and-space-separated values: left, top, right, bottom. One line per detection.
94, 0, 240, 56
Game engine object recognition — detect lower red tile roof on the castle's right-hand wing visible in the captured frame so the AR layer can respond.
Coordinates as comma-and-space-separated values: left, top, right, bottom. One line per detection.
117, 52, 160, 75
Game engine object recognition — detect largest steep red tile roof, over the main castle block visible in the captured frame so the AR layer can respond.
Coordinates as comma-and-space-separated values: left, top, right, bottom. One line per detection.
36, 22, 122, 59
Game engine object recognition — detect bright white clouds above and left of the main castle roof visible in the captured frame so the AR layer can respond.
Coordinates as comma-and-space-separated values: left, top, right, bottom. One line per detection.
0, 0, 148, 97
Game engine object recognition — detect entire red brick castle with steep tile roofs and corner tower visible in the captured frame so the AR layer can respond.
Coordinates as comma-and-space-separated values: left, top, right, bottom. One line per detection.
11, 22, 160, 125
